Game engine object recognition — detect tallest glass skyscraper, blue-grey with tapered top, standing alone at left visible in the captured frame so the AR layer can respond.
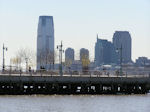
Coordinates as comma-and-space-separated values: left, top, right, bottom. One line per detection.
37, 16, 54, 70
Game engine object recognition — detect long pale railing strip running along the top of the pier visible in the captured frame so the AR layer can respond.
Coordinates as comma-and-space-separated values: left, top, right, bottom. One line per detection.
0, 70, 150, 78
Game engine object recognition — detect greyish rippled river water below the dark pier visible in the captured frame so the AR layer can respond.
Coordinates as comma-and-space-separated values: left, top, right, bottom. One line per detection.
0, 94, 150, 112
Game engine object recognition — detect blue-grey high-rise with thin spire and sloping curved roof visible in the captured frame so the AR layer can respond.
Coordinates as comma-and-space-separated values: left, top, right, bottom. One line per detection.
95, 36, 117, 66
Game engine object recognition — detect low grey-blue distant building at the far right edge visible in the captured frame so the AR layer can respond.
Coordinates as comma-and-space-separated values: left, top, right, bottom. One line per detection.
135, 57, 150, 66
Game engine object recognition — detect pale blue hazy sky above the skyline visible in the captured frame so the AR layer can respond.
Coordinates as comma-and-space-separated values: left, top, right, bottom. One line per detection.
0, 0, 150, 65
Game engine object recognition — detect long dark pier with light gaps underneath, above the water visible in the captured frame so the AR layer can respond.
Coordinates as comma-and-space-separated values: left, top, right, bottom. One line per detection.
0, 75, 150, 95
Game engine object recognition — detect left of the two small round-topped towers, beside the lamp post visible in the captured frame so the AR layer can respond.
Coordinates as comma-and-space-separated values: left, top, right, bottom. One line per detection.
65, 48, 74, 62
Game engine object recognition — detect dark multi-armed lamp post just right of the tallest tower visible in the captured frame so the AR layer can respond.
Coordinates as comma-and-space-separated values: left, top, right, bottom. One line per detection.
57, 41, 64, 76
